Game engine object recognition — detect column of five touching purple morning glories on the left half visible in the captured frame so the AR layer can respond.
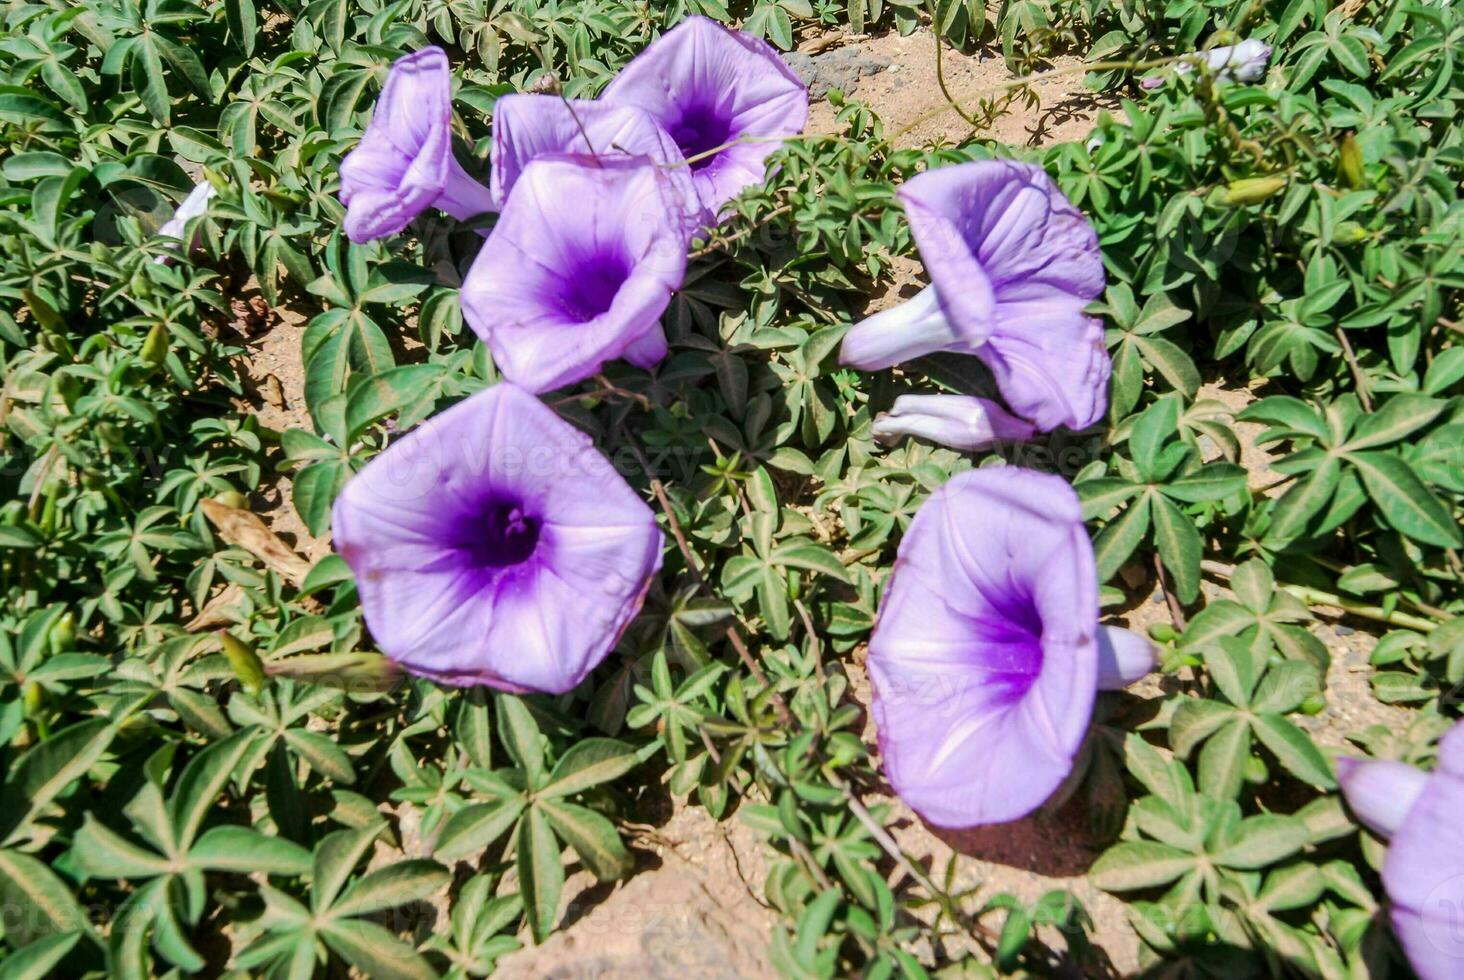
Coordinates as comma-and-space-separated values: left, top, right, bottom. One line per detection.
332, 18, 808, 693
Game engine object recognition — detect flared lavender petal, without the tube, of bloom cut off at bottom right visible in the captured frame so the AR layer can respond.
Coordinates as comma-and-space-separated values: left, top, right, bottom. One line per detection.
1376, 722, 1464, 980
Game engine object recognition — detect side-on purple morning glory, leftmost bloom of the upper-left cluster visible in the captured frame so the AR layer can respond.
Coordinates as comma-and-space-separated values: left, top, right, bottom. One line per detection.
341, 47, 493, 242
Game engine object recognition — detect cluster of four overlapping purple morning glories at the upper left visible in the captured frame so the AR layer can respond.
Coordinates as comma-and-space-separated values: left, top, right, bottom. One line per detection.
341, 16, 808, 393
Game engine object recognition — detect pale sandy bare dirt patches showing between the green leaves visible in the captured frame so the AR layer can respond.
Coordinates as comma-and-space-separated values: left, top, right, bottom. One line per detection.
225, 24, 1404, 980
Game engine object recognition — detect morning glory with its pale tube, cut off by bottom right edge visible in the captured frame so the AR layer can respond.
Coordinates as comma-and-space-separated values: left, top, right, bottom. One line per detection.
1337, 722, 1464, 980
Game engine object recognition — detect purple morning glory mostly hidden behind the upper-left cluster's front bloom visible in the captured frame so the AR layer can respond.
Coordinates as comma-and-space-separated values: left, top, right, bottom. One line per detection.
489, 94, 700, 218
